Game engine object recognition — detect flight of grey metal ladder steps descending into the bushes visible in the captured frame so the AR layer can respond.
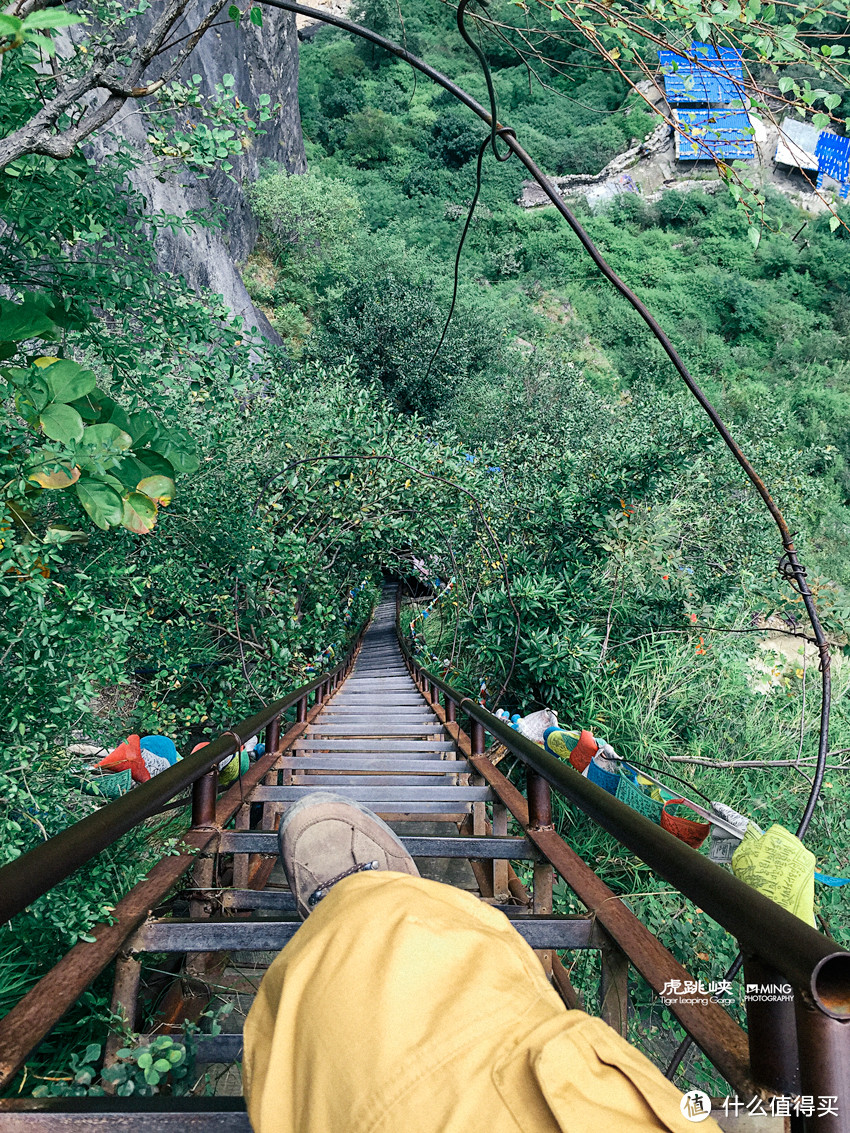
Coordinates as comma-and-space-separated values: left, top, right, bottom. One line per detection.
120, 590, 584, 1090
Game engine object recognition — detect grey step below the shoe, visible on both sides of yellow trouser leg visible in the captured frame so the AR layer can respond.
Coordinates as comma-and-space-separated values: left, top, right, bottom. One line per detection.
128, 915, 603, 953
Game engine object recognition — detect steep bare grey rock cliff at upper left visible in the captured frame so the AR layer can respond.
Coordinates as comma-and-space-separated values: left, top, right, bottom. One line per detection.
101, 0, 306, 341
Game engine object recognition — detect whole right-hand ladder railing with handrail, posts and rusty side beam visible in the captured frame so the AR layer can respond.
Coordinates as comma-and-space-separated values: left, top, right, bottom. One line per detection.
398, 597, 850, 1119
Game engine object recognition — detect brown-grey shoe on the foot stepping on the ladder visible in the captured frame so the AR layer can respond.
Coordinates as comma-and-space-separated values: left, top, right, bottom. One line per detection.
278, 791, 419, 920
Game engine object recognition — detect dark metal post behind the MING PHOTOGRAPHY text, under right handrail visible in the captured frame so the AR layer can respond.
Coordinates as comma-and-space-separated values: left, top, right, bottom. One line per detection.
743, 956, 800, 1094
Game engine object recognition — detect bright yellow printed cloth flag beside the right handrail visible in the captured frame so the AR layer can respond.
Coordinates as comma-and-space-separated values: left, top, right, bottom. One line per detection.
732, 823, 815, 925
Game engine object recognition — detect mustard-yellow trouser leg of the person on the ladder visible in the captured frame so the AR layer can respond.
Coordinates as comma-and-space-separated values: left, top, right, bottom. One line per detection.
244, 872, 719, 1133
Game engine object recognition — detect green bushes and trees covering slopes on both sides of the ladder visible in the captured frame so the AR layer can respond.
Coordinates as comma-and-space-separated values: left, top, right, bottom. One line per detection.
0, 0, 850, 1101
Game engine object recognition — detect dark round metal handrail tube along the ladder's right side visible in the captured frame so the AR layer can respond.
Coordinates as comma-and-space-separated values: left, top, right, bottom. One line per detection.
399, 602, 850, 1020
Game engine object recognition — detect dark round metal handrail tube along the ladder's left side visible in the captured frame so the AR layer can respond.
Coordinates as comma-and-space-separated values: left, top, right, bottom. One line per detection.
0, 619, 369, 925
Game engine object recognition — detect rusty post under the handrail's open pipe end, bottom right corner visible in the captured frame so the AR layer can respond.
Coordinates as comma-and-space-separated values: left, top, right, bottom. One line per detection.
792, 991, 850, 1133
